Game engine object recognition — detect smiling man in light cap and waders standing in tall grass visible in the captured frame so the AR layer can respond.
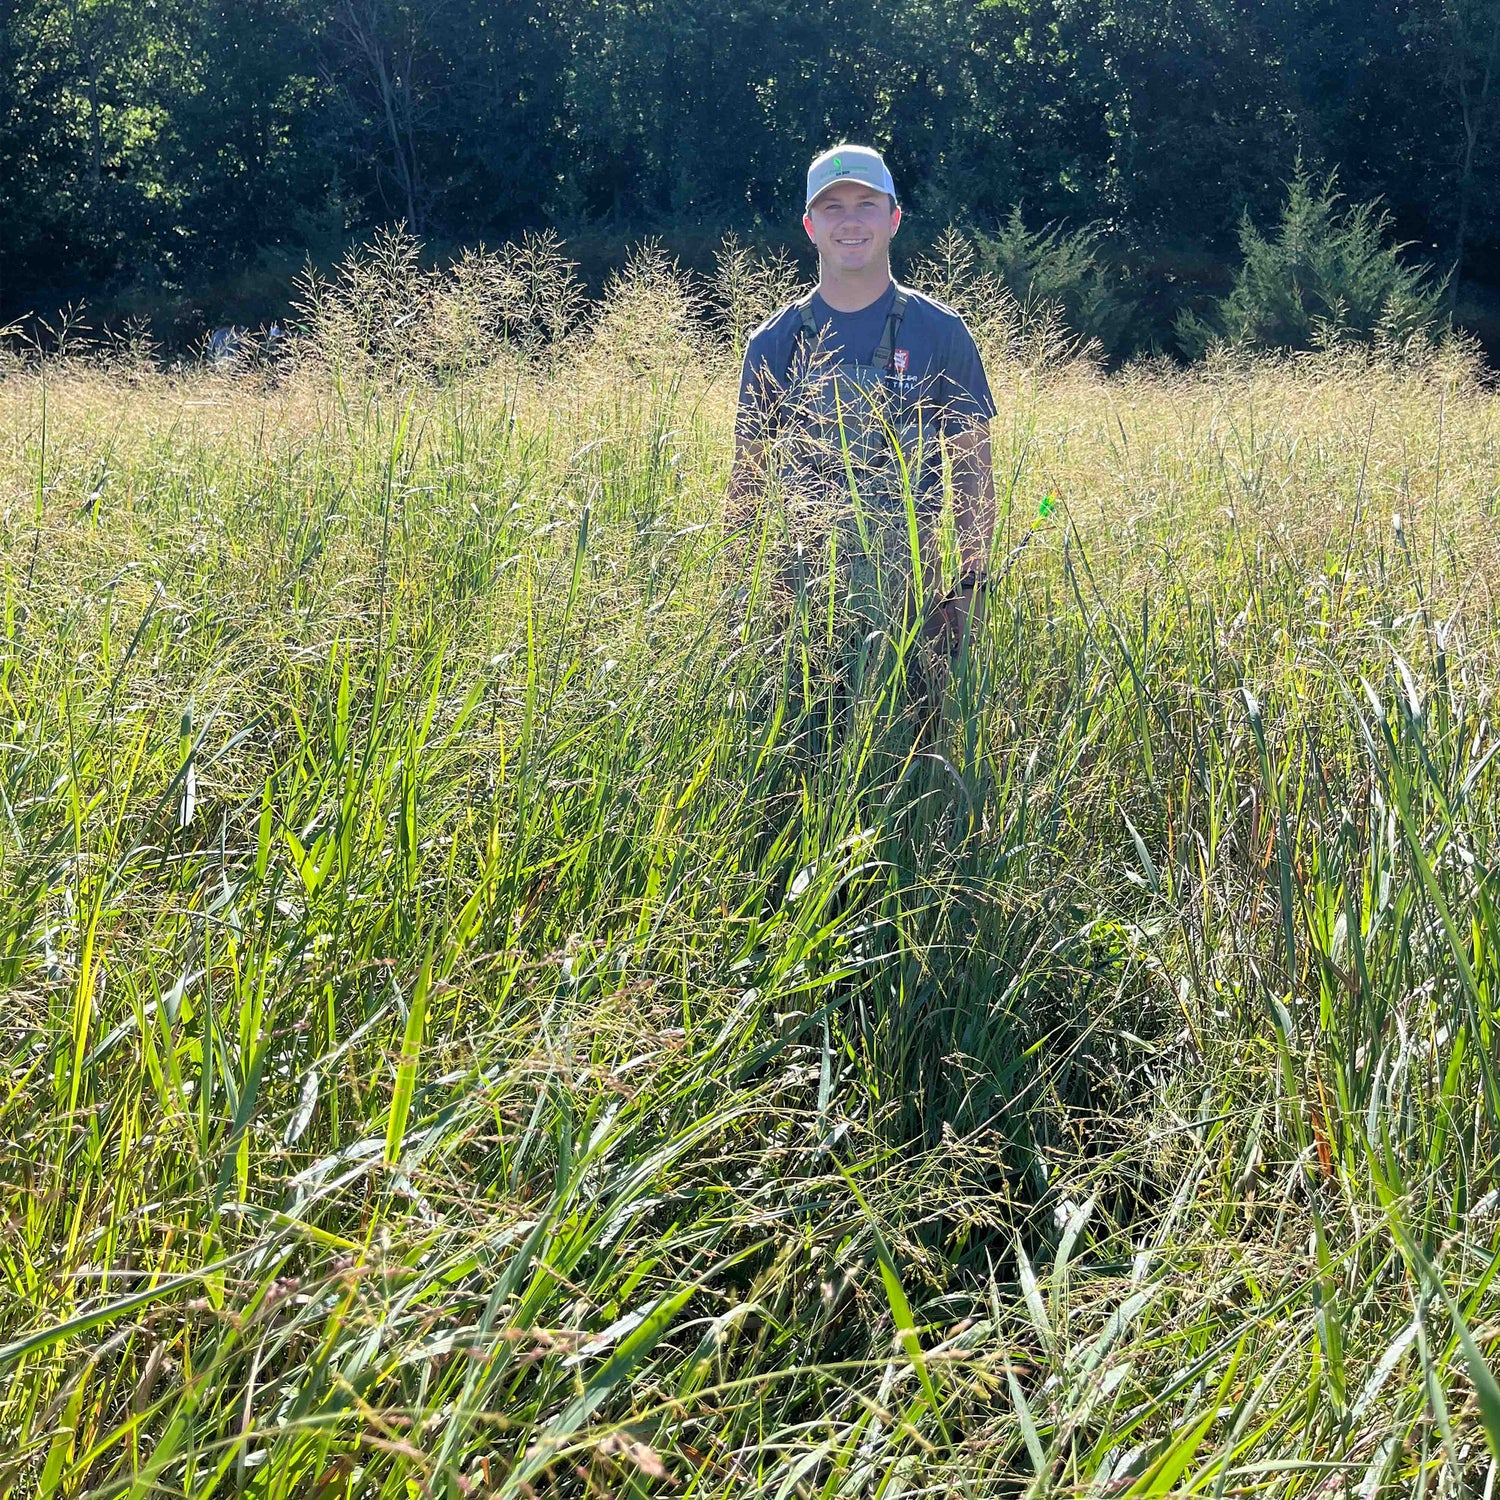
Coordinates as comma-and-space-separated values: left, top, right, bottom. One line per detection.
731, 144, 995, 651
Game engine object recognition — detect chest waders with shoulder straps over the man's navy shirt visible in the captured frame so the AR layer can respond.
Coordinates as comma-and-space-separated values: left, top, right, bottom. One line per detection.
779, 287, 941, 623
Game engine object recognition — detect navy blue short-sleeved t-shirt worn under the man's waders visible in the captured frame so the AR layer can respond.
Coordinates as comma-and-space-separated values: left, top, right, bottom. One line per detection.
735, 282, 995, 441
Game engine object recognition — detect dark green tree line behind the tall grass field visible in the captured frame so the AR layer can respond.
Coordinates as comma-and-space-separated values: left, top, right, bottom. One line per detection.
0, 0, 1500, 343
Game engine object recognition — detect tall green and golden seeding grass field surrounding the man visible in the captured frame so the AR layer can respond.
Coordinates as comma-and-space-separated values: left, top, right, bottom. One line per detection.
0, 243, 1500, 1500
